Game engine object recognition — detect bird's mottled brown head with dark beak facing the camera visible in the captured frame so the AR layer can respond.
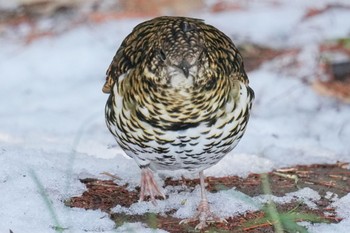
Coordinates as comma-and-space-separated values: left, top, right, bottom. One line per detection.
144, 18, 215, 89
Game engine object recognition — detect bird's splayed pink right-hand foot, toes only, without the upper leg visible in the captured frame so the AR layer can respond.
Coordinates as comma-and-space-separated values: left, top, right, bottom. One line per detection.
180, 200, 227, 230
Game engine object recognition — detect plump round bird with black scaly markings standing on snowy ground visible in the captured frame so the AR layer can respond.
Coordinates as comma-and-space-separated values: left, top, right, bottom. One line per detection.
102, 16, 254, 229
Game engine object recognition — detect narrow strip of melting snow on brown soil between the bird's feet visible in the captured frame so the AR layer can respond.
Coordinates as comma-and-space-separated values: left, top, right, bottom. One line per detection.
112, 186, 321, 219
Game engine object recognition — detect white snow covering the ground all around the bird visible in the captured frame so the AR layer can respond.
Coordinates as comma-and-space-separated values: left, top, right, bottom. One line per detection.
0, 0, 350, 233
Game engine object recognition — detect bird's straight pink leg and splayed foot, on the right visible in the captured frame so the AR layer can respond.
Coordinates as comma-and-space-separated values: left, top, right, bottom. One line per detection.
180, 171, 227, 230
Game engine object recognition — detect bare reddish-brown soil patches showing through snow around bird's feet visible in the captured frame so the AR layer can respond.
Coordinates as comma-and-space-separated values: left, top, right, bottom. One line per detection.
66, 163, 350, 232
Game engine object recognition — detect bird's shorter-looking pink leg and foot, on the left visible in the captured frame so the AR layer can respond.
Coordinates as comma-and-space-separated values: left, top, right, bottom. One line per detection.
140, 167, 165, 205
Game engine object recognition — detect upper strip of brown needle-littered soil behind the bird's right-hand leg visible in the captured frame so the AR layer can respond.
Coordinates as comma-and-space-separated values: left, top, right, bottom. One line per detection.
165, 163, 350, 197
